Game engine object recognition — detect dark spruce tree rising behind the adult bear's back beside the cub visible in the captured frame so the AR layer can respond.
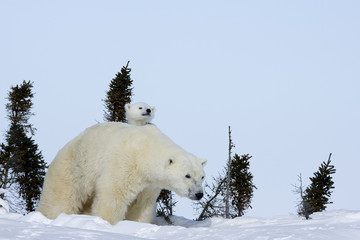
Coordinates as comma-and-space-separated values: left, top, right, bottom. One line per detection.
104, 61, 133, 122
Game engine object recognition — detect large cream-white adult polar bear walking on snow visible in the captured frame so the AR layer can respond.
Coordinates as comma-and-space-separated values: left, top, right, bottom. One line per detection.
37, 122, 206, 224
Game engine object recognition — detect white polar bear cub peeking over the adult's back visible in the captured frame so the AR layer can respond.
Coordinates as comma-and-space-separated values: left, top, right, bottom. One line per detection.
125, 102, 156, 126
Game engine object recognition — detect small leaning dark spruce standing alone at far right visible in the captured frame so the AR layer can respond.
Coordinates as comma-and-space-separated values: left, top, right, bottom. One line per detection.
305, 153, 336, 214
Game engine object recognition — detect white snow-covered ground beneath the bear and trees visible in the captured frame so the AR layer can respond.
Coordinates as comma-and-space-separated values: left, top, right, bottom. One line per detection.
0, 210, 360, 240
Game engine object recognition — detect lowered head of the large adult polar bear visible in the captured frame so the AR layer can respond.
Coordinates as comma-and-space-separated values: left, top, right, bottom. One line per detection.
165, 154, 206, 200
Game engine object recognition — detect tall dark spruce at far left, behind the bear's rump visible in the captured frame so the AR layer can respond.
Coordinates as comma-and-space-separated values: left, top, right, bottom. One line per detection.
1, 81, 47, 212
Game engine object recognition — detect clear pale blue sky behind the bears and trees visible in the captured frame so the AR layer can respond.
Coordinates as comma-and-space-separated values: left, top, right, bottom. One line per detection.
0, 0, 360, 217
